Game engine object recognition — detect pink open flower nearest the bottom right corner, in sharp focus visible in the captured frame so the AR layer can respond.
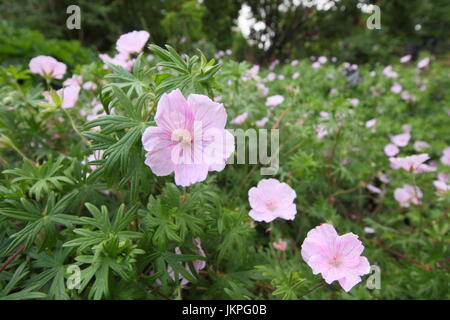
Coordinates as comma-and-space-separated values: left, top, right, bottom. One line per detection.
301, 223, 370, 292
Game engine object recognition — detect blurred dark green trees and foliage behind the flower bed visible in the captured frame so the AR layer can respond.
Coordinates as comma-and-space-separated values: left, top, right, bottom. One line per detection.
0, 0, 450, 65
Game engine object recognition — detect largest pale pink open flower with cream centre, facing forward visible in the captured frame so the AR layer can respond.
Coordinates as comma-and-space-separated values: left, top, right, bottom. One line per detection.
142, 89, 234, 186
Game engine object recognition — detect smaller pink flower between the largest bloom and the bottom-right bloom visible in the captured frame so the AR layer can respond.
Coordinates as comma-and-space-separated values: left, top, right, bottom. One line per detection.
248, 179, 297, 222
